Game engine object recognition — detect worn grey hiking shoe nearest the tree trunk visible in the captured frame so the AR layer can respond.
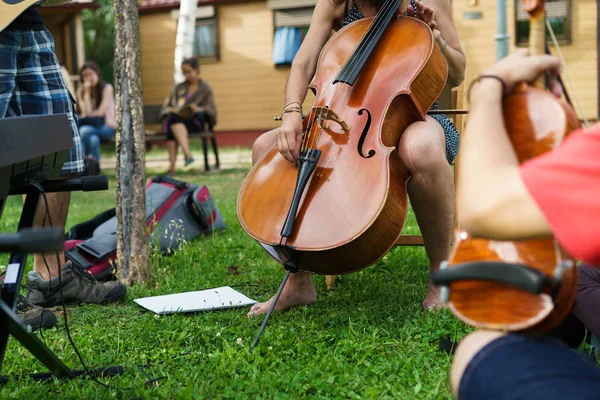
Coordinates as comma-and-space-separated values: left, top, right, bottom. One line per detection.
27, 261, 127, 307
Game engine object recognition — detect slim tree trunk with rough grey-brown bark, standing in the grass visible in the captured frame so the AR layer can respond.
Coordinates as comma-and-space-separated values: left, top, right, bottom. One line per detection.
114, 0, 151, 285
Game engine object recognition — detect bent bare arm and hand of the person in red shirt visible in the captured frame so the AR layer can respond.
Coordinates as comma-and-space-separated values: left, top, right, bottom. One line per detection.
456, 50, 560, 240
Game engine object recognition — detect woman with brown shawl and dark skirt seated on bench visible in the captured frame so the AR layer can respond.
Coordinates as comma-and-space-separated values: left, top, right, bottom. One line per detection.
160, 58, 217, 175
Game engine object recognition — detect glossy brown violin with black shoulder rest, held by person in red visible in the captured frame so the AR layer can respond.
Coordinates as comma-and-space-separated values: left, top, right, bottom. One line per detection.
434, 0, 579, 333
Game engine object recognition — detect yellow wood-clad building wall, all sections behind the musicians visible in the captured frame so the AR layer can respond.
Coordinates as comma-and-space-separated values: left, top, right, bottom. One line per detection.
140, 0, 598, 135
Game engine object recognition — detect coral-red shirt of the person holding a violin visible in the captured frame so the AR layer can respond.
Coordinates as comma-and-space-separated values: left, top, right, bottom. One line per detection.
521, 125, 600, 266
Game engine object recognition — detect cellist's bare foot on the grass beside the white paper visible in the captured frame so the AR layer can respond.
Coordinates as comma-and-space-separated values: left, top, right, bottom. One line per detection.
248, 272, 317, 317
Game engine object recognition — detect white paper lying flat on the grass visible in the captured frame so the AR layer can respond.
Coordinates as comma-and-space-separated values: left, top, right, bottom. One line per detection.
134, 286, 256, 314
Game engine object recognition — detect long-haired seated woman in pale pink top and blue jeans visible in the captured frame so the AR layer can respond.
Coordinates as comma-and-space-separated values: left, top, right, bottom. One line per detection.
77, 61, 117, 160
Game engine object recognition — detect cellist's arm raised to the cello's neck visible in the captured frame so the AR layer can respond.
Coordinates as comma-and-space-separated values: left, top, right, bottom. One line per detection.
418, 0, 467, 87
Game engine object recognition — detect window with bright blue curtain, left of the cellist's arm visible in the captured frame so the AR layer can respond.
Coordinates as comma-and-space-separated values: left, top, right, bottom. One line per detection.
273, 7, 314, 66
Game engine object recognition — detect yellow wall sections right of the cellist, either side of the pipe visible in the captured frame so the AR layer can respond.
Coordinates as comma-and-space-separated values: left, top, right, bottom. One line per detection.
453, 0, 598, 119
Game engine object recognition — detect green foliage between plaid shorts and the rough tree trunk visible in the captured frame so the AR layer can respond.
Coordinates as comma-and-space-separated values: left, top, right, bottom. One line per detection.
81, 0, 115, 83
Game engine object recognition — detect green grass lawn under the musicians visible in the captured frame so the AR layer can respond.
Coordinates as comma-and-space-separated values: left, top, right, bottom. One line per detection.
0, 163, 468, 399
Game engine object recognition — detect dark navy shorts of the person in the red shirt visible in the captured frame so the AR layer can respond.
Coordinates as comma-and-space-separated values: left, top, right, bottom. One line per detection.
458, 334, 600, 400
